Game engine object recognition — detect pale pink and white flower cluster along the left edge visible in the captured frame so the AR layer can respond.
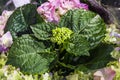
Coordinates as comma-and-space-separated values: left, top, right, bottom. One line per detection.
0, 10, 13, 52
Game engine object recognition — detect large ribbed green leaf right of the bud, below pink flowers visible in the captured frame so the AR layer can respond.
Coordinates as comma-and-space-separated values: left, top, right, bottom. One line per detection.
59, 9, 105, 48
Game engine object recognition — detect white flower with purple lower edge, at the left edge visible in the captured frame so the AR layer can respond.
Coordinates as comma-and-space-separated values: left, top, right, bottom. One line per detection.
0, 31, 13, 52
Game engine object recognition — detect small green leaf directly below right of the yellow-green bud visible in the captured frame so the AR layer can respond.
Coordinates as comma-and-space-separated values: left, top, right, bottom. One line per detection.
63, 34, 89, 56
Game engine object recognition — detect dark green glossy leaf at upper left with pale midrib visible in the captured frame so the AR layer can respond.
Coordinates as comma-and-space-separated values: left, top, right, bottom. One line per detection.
5, 4, 43, 38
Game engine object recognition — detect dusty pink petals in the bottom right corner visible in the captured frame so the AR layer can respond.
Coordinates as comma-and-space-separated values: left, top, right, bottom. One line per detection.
94, 67, 116, 80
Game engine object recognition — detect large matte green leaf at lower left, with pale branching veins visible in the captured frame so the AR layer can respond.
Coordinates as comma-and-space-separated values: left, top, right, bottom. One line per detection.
7, 35, 56, 74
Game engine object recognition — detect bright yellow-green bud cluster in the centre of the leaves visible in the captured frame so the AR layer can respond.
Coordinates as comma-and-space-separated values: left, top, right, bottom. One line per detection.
51, 27, 73, 45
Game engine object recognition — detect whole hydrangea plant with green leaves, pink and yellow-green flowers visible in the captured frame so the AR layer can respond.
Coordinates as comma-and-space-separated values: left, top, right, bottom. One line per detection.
0, 0, 120, 80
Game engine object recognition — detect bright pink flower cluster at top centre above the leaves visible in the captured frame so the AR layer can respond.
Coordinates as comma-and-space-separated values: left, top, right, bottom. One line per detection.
37, 0, 88, 23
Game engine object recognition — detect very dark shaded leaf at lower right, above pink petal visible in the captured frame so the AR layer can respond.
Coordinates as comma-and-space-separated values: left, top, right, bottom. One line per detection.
76, 43, 115, 72
